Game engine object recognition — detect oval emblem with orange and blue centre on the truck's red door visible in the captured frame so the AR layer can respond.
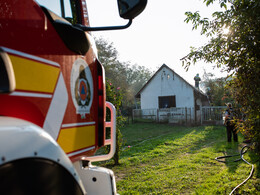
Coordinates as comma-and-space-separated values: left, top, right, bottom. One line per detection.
71, 59, 93, 118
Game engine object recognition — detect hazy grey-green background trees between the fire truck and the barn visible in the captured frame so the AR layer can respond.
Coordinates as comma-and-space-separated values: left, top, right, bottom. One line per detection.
96, 38, 152, 109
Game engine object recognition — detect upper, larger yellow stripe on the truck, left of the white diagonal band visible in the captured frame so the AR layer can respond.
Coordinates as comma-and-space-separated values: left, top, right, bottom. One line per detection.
9, 54, 60, 93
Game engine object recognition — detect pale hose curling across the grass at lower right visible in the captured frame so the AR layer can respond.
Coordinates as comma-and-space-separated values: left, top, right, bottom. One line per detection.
215, 145, 254, 195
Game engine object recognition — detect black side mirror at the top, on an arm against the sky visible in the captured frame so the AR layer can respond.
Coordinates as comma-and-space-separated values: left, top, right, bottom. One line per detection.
117, 0, 147, 19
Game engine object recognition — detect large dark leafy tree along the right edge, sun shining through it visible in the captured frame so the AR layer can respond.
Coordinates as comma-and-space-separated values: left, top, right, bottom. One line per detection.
182, 0, 260, 150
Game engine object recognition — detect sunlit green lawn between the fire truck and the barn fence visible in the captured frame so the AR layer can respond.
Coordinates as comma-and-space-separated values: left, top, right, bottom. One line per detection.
104, 123, 260, 195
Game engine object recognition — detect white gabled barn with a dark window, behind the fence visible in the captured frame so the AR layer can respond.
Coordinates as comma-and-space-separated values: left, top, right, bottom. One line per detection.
135, 64, 209, 121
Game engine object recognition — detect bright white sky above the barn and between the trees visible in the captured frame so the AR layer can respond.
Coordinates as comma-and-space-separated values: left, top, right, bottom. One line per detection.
86, 0, 227, 85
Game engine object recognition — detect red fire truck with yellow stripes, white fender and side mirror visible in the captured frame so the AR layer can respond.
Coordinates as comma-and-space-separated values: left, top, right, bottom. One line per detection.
0, 0, 147, 195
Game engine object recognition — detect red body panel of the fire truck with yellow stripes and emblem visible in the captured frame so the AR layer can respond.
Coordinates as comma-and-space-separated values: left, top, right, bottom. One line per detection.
0, 0, 105, 161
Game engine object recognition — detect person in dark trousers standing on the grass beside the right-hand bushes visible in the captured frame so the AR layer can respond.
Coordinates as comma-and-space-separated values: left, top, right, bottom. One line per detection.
225, 103, 238, 142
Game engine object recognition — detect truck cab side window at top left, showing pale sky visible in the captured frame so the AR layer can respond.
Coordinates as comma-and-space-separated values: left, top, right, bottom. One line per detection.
36, 0, 80, 24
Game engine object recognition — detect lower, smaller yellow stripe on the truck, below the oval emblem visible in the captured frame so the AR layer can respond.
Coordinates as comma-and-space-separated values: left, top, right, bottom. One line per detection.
57, 126, 96, 153
